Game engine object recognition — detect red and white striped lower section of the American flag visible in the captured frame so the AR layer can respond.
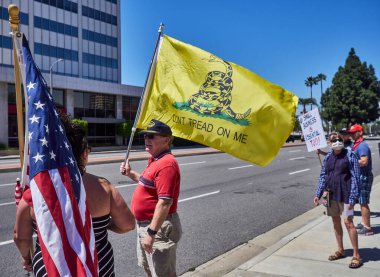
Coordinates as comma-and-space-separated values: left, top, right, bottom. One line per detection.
30, 168, 97, 276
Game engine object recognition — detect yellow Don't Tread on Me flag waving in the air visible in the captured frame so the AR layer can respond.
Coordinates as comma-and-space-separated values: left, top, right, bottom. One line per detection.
137, 36, 298, 166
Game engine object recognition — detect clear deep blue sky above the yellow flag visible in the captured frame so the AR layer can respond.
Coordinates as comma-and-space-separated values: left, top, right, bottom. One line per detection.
120, 0, 380, 113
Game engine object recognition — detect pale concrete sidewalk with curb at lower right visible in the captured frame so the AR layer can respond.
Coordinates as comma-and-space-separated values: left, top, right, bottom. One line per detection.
182, 176, 380, 277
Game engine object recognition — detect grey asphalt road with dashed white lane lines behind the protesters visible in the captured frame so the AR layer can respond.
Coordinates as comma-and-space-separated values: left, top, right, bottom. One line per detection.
0, 141, 380, 276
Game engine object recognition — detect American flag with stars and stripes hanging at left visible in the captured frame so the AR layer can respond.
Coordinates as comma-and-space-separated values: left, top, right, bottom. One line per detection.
14, 33, 98, 276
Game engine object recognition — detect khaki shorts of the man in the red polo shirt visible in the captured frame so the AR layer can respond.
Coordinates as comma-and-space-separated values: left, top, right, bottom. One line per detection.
137, 213, 182, 277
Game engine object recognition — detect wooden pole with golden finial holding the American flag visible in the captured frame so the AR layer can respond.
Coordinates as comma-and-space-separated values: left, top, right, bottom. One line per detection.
8, 4, 24, 168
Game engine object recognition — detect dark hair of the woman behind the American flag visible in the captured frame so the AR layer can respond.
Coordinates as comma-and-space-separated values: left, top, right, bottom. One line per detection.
59, 113, 88, 174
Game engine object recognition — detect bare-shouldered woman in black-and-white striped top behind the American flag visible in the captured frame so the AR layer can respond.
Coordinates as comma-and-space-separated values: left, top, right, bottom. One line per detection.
14, 116, 135, 277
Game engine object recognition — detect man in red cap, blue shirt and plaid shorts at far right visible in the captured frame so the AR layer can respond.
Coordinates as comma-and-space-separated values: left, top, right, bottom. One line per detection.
348, 124, 373, 236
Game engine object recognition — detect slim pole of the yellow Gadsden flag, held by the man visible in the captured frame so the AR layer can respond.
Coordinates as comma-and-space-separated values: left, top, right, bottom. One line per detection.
125, 23, 164, 160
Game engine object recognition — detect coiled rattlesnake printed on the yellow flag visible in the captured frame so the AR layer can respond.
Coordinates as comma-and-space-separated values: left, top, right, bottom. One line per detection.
189, 55, 251, 120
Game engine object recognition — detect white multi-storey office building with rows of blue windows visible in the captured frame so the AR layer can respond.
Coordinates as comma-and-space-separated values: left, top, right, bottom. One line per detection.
0, 0, 143, 147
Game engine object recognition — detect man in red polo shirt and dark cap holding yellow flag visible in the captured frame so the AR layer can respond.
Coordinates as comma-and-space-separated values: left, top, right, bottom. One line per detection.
120, 119, 182, 277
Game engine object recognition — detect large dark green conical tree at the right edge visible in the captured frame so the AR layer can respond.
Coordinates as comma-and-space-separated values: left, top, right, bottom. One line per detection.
321, 48, 380, 127
